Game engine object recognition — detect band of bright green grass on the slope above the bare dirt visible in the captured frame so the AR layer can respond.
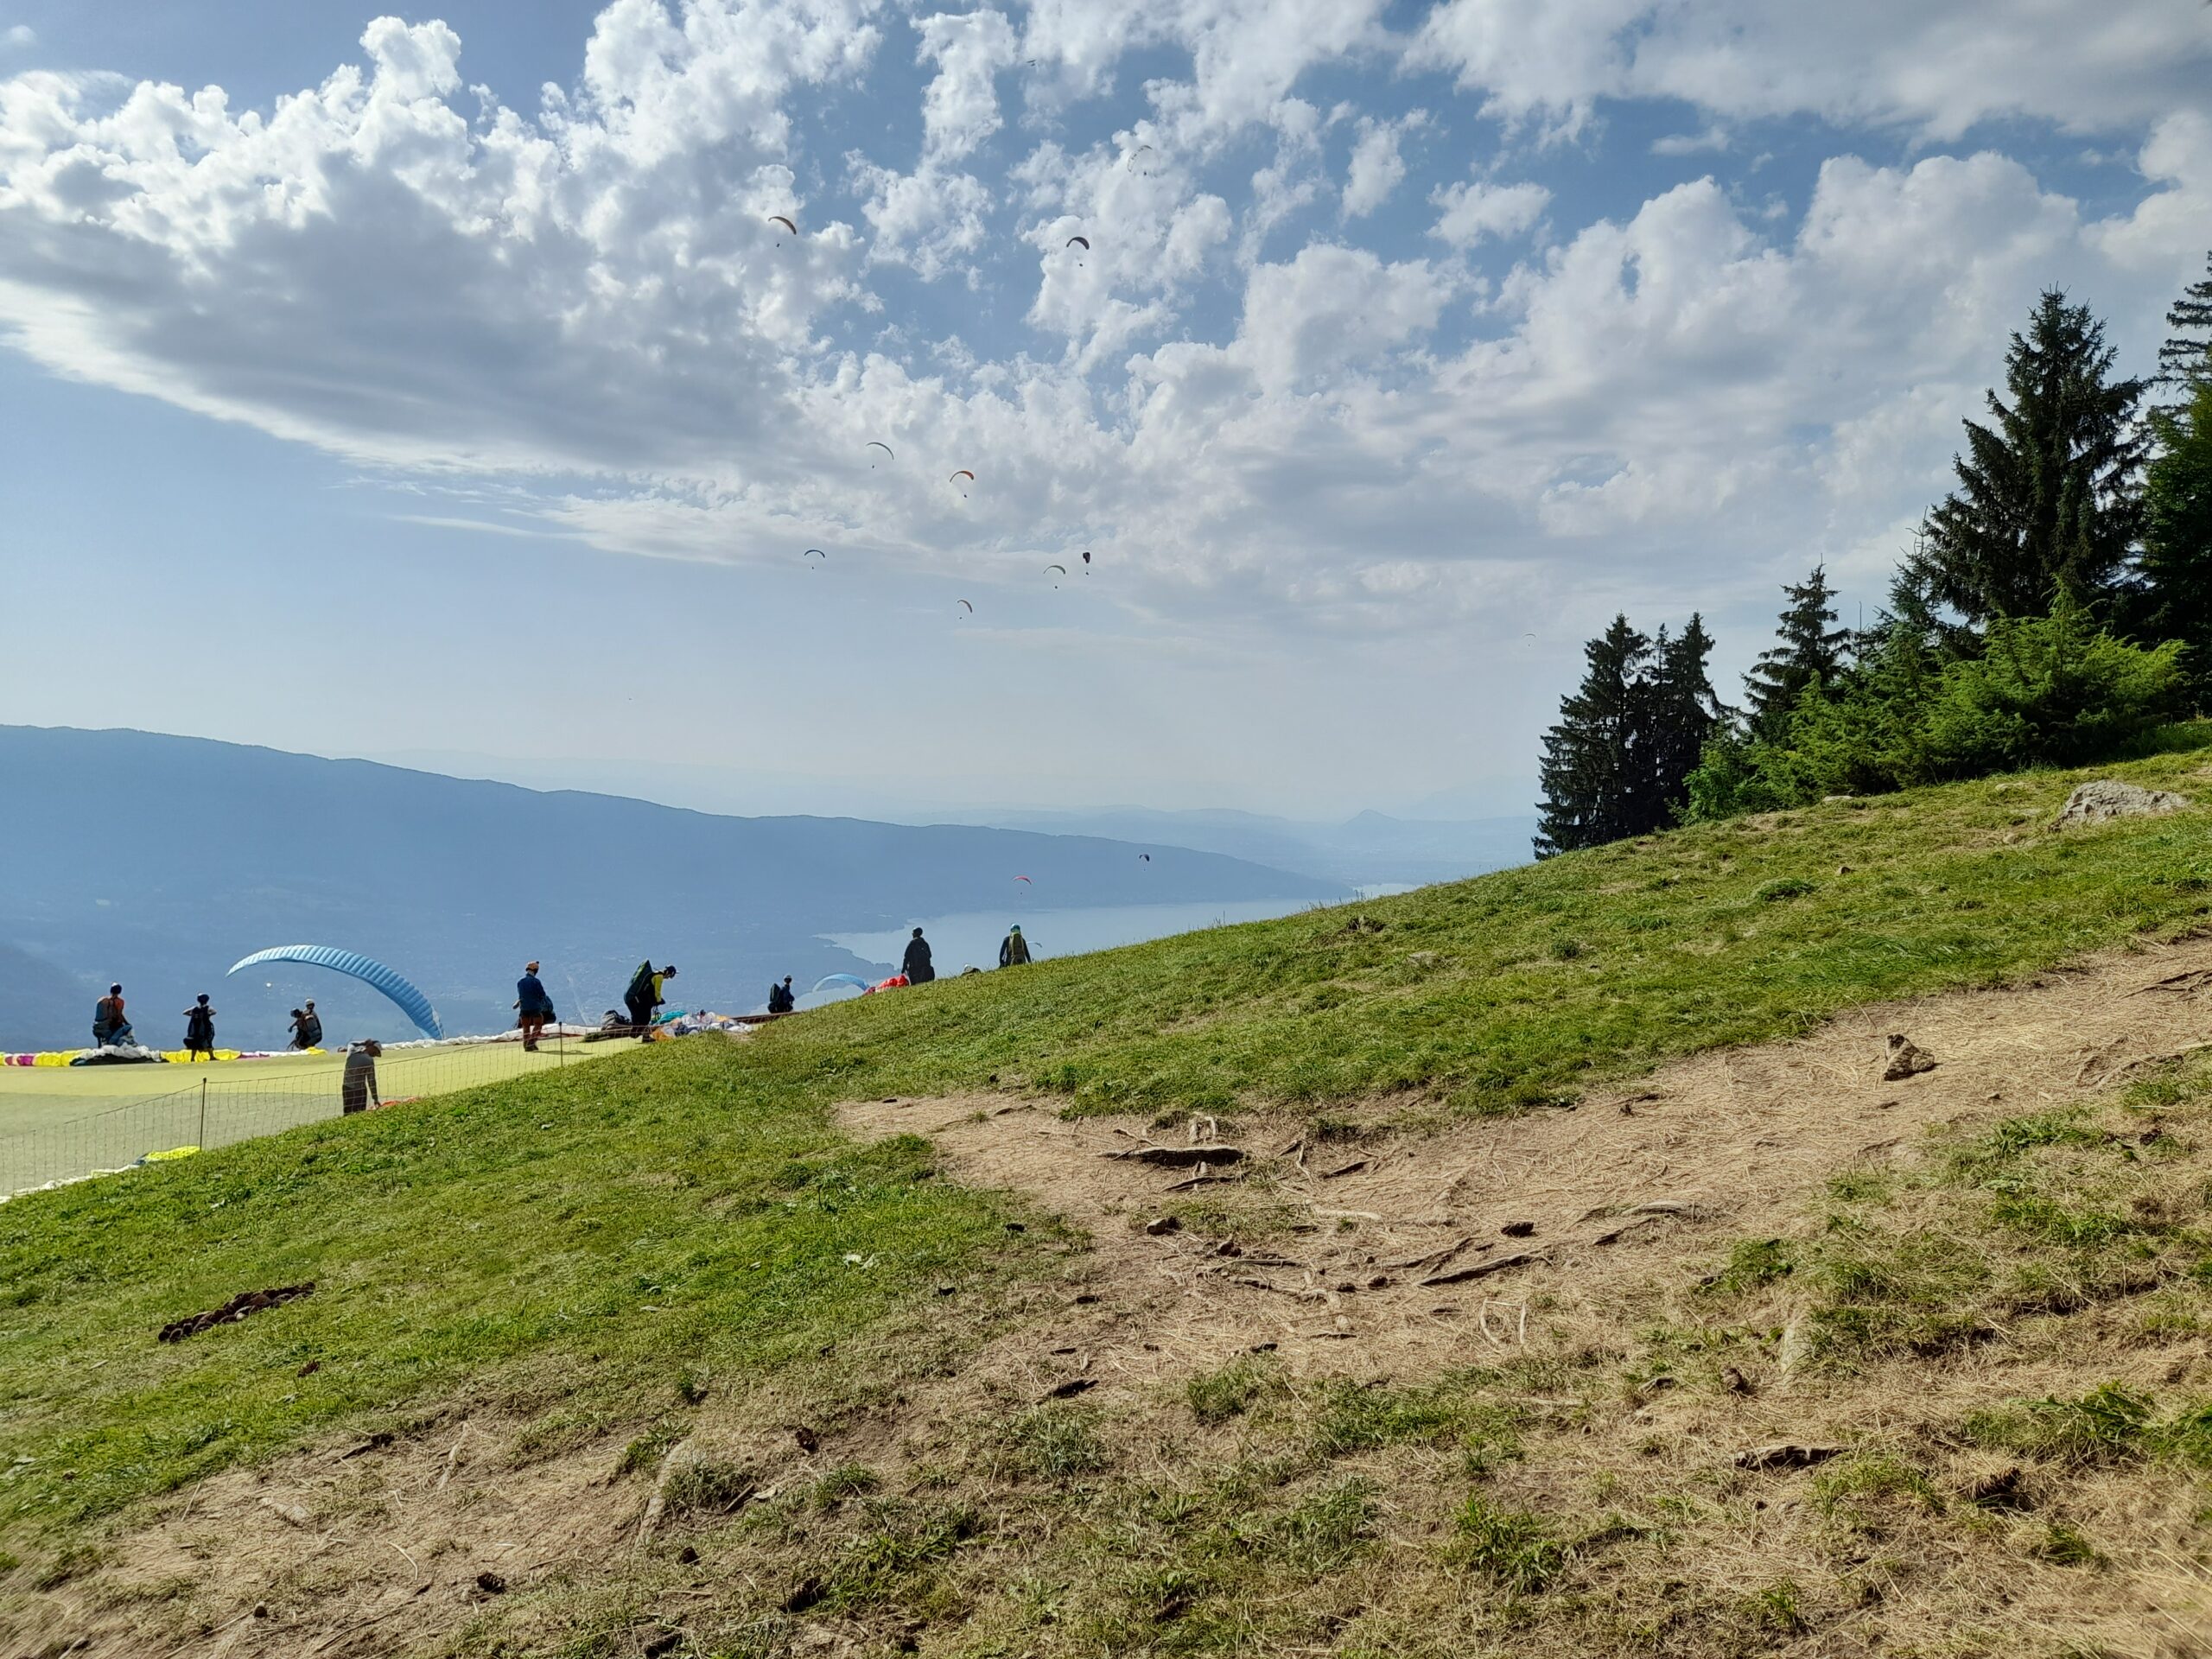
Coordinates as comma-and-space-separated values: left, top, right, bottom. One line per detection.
0, 752, 2212, 1637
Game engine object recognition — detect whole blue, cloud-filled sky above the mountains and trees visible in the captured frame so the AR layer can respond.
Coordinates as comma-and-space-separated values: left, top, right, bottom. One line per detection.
0, 0, 2212, 817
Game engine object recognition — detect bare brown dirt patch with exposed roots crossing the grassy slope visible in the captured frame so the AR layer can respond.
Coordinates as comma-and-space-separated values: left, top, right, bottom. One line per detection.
841, 940, 2212, 1391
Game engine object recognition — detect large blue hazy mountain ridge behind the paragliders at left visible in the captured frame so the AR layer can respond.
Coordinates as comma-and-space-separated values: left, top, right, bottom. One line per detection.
0, 726, 1343, 1046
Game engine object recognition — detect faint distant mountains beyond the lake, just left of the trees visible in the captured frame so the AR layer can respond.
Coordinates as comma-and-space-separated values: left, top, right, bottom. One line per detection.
960, 807, 1535, 887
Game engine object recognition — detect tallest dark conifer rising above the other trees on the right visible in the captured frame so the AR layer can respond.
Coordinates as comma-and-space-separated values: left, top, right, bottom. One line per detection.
1891, 289, 2150, 626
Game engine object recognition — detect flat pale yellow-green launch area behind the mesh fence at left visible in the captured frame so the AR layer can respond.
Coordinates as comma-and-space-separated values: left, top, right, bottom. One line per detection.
0, 1035, 635, 1194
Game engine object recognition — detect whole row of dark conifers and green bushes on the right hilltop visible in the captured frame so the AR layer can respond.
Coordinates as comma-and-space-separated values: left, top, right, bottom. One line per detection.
1535, 254, 2212, 858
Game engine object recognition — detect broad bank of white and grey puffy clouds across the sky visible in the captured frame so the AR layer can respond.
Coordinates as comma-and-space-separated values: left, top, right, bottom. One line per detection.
0, 0, 2212, 637
